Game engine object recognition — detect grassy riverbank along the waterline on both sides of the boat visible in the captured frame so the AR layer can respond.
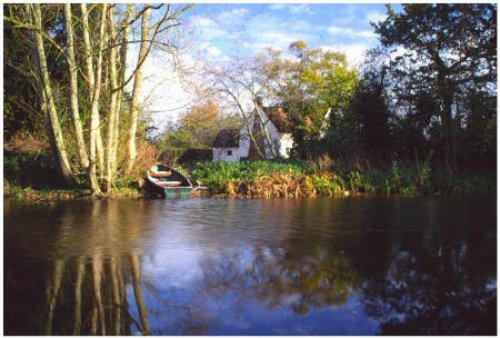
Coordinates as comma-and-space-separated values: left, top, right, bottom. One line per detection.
4, 152, 496, 201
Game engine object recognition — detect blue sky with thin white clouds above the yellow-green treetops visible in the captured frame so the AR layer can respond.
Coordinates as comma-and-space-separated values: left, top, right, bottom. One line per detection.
182, 3, 398, 62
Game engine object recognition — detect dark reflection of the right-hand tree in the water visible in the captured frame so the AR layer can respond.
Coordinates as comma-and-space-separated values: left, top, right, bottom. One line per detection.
355, 199, 496, 335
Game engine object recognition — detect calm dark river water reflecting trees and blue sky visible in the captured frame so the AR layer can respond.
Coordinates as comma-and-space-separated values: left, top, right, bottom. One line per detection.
4, 198, 497, 335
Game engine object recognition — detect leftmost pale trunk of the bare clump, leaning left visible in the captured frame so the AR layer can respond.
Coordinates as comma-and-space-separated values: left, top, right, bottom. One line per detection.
33, 4, 73, 184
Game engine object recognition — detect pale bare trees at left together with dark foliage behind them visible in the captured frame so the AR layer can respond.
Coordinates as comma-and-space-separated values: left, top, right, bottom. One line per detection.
5, 4, 191, 196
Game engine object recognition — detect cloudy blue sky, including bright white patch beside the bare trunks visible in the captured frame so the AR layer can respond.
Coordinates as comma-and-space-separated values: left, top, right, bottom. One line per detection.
132, 3, 399, 130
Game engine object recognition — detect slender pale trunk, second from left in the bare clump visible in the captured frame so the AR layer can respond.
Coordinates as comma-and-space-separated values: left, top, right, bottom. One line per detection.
64, 3, 89, 169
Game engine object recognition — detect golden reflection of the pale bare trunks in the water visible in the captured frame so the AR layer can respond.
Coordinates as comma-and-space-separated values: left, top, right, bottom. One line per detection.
6, 202, 156, 335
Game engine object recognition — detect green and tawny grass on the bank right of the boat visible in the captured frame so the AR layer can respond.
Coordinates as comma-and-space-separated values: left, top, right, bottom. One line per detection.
191, 161, 496, 198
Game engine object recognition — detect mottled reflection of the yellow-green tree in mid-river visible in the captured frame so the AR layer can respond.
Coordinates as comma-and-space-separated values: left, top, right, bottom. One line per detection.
196, 236, 356, 314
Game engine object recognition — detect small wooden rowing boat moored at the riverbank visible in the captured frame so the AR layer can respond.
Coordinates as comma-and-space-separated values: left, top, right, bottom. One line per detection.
146, 164, 194, 198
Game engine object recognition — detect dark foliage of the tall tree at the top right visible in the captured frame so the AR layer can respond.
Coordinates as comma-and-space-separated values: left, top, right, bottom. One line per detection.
374, 4, 497, 170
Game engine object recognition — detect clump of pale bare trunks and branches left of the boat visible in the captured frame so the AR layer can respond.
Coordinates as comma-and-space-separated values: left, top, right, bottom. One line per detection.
9, 4, 191, 196
